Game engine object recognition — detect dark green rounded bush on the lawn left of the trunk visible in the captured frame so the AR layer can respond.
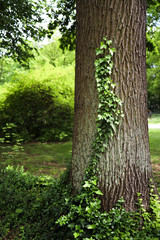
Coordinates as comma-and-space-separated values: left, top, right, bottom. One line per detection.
0, 80, 73, 142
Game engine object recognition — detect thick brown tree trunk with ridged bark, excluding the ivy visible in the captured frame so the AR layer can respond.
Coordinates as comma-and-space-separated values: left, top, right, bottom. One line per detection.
71, 0, 152, 210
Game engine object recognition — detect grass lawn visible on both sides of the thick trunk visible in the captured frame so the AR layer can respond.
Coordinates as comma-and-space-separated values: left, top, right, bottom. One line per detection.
0, 114, 160, 188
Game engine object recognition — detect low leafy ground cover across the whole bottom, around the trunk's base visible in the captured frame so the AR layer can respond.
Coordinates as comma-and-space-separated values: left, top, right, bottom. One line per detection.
0, 167, 160, 240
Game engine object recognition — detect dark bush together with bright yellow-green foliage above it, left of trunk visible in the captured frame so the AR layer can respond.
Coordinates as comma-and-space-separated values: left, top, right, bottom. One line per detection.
0, 39, 75, 142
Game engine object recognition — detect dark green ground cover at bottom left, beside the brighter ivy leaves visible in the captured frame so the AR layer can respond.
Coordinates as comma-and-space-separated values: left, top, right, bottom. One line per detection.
0, 166, 72, 240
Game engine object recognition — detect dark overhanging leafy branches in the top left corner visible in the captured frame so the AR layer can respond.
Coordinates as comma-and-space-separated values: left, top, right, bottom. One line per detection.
0, 0, 50, 64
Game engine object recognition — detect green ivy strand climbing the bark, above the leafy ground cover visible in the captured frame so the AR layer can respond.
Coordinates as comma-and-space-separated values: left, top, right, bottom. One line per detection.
86, 38, 123, 180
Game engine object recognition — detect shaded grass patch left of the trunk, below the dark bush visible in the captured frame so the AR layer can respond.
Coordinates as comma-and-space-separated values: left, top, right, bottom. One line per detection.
0, 142, 72, 177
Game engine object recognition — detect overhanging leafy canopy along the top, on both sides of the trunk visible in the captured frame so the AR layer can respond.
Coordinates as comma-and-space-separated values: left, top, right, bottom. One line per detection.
0, 0, 160, 64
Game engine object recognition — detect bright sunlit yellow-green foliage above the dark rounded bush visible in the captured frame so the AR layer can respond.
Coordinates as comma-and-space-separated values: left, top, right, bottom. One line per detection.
0, 37, 75, 85
